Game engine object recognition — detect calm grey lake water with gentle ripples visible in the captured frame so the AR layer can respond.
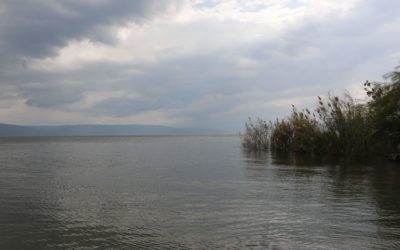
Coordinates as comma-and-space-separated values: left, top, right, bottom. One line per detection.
0, 136, 400, 249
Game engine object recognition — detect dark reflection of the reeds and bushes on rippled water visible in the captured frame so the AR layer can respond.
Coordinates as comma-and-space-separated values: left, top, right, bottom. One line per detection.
243, 151, 400, 249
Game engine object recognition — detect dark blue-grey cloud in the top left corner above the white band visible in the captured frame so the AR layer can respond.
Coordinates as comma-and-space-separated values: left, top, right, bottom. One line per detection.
0, 0, 178, 57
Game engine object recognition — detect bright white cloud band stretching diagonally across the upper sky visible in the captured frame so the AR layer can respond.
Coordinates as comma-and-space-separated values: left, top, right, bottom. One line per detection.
28, 0, 356, 70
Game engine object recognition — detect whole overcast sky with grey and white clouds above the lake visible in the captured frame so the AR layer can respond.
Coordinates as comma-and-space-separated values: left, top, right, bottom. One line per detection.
0, 0, 400, 131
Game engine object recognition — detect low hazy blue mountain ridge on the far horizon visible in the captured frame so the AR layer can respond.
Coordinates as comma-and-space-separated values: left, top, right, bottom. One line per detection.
0, 123, 221, 136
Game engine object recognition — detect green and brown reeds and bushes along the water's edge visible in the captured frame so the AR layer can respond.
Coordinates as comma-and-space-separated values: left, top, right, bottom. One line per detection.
241, 67, 400, 161
